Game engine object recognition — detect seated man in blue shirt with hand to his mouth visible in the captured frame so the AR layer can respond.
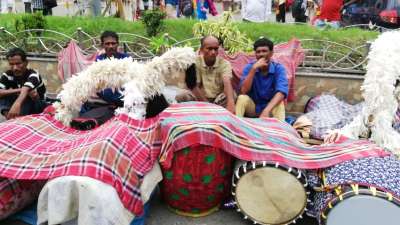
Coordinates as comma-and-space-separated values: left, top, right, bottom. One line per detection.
236, 38, 289, 121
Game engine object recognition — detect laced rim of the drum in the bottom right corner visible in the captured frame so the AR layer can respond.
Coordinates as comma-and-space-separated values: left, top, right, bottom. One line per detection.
319, 183, 400, 225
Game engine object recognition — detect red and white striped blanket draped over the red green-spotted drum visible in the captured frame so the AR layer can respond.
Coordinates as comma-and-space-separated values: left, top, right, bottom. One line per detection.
160, 103, 389, 169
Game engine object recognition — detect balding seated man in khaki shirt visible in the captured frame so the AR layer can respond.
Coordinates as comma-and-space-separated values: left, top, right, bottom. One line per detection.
176, 36, 235, 113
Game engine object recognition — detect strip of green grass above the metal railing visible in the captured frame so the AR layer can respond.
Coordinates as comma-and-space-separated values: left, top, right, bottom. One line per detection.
0, 14, 379, 46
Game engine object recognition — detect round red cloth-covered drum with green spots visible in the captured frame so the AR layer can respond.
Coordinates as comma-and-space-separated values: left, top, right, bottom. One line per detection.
161, 145, 233, 217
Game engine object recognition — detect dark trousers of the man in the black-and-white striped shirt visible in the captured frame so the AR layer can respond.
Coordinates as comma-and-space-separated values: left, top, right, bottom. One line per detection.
0, 95, 46, 116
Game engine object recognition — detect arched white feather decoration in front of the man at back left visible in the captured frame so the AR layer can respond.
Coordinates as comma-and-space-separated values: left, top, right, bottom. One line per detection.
53, 47, 196, 125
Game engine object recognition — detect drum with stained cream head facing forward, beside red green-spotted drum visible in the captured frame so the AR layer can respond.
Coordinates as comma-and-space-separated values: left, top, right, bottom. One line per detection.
232, 162, 309, 225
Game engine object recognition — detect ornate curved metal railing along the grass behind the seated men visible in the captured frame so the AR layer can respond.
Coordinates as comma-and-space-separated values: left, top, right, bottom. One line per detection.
0, 28, 369, 74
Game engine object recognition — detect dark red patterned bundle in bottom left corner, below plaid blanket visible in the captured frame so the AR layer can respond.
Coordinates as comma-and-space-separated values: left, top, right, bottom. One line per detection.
0, 178, 46, 220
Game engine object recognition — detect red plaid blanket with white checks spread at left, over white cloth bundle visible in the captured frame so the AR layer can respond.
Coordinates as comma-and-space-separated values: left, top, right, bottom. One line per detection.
0, 114, 161, 214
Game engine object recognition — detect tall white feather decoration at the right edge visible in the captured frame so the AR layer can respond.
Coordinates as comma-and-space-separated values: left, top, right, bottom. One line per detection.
340, 31, 400, 155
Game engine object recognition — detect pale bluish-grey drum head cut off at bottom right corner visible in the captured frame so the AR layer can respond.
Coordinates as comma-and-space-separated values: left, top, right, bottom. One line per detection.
326, 195, 400, 225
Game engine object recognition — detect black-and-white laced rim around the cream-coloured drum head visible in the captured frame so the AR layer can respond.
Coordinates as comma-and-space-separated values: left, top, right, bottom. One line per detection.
232, 161, 311, 225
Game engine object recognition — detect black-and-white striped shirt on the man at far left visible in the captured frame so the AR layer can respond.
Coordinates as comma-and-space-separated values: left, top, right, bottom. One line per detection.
0, 69, 46, 100
